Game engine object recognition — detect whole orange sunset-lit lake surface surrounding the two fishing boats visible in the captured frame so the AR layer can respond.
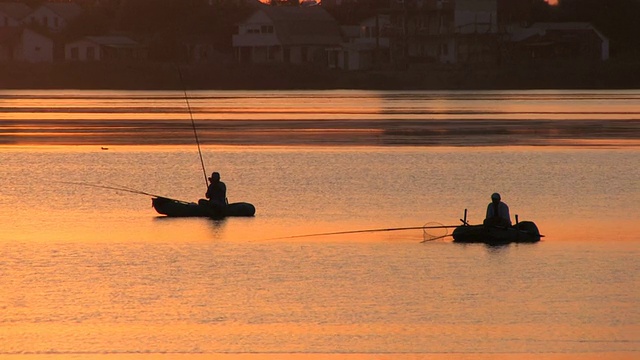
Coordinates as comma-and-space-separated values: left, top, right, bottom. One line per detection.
0, 92, 640, 360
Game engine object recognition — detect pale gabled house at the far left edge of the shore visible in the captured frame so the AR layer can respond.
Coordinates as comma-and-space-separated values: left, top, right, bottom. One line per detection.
0, 27, 53, 63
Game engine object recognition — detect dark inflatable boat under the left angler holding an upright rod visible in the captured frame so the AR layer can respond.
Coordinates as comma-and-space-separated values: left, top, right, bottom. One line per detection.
151, 196, 256, 218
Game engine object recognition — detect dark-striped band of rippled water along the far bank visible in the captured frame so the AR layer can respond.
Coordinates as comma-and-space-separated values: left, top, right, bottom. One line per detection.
0, 90, 640, 146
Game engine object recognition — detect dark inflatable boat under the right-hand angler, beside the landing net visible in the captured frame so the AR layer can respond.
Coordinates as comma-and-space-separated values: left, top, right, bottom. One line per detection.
452, 221, 543, 245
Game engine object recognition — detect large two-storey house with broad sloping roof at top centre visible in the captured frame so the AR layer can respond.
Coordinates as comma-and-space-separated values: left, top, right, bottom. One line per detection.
232, 5, 342, 64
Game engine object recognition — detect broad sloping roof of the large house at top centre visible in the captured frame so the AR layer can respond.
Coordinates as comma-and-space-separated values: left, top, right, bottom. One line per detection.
258, 5, 342, 45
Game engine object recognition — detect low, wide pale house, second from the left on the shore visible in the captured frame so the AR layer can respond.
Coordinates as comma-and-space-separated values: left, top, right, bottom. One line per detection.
64, 35, 148, 61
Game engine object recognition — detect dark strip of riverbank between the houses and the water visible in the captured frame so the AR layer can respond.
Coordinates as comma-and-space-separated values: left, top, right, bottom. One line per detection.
0, 59, 640, 90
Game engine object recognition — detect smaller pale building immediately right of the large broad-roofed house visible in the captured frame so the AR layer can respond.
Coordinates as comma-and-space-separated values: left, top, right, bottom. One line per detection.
329, 15, 391, 70
